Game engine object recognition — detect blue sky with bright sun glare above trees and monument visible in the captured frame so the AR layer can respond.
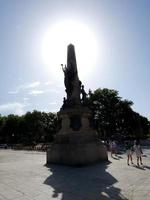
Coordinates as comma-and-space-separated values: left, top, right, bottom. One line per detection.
0, 0, 150, 119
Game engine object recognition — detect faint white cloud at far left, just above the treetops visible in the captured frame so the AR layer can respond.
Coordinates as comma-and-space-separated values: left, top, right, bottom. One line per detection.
0, 102, 25, 115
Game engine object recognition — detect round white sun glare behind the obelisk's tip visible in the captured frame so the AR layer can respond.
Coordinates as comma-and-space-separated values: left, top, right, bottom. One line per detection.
42, 21, 98, 78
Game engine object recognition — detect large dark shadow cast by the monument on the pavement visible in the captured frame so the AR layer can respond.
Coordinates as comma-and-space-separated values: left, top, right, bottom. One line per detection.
44, 162, 127, 200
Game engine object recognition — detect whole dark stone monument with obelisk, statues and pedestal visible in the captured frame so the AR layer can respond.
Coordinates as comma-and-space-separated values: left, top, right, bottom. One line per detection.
47, 44, 108, 166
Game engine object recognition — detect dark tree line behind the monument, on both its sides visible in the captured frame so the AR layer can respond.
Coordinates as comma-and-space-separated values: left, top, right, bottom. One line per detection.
0, 88, 150, 145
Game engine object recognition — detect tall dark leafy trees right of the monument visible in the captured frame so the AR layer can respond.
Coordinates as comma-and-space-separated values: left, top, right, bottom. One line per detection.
88, 88, 149, 139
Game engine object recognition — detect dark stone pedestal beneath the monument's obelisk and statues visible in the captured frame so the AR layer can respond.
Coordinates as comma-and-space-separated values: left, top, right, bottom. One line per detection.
47, 106, 108, 166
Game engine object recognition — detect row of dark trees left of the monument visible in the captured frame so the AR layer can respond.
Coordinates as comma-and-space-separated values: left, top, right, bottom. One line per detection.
0, 110, 57, 144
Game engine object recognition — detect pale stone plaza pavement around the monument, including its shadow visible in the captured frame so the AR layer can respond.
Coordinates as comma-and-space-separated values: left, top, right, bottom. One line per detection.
0, 149, 150, 200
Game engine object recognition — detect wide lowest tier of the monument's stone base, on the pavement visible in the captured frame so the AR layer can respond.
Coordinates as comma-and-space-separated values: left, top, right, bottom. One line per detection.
47, 134, 108, 166
